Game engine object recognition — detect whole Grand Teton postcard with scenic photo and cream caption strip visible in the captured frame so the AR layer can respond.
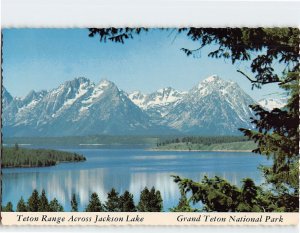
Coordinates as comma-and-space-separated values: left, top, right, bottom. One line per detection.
1, 27, 300, 226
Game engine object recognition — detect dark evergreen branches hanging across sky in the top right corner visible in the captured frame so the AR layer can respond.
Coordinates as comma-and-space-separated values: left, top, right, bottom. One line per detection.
180, 28, 300, 87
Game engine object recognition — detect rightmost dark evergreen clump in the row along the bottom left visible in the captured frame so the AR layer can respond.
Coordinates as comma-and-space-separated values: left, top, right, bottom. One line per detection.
137, 187, 163, 212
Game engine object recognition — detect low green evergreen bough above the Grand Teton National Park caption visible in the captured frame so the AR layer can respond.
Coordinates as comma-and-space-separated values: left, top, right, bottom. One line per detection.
174, 176, 274, 212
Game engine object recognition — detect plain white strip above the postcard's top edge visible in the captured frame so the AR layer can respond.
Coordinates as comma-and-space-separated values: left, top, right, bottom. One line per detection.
1, 0, 300, 27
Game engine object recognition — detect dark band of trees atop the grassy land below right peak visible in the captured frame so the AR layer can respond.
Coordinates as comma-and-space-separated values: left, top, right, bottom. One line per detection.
157, 136, 250, 147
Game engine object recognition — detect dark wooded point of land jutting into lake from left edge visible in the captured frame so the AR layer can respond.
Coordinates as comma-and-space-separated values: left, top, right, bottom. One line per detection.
1, 144, 86, 168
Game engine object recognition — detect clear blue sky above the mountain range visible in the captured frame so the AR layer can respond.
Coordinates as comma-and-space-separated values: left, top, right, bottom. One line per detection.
3, 29, 281, 100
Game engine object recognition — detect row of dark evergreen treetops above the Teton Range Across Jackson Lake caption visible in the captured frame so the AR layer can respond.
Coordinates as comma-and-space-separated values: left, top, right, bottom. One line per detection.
2, 187, 163, 212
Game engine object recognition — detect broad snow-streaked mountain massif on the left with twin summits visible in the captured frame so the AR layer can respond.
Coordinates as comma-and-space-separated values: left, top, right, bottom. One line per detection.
3, 78, 168, 136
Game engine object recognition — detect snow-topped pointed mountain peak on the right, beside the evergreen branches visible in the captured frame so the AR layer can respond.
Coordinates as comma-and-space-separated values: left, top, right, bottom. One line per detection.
166, 75, 255, 135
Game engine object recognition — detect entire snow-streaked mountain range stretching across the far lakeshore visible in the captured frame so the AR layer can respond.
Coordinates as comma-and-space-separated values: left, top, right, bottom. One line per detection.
2, 75, 284, 137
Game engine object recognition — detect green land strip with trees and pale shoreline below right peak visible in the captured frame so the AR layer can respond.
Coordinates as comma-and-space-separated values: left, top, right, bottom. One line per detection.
153, 136, 256, 152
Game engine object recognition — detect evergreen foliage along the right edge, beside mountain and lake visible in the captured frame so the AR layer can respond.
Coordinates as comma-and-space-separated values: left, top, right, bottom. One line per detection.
240, 72, 299, 212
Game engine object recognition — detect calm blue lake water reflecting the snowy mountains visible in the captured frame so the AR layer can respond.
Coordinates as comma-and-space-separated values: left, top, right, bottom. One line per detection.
2, 148, 270, 211
